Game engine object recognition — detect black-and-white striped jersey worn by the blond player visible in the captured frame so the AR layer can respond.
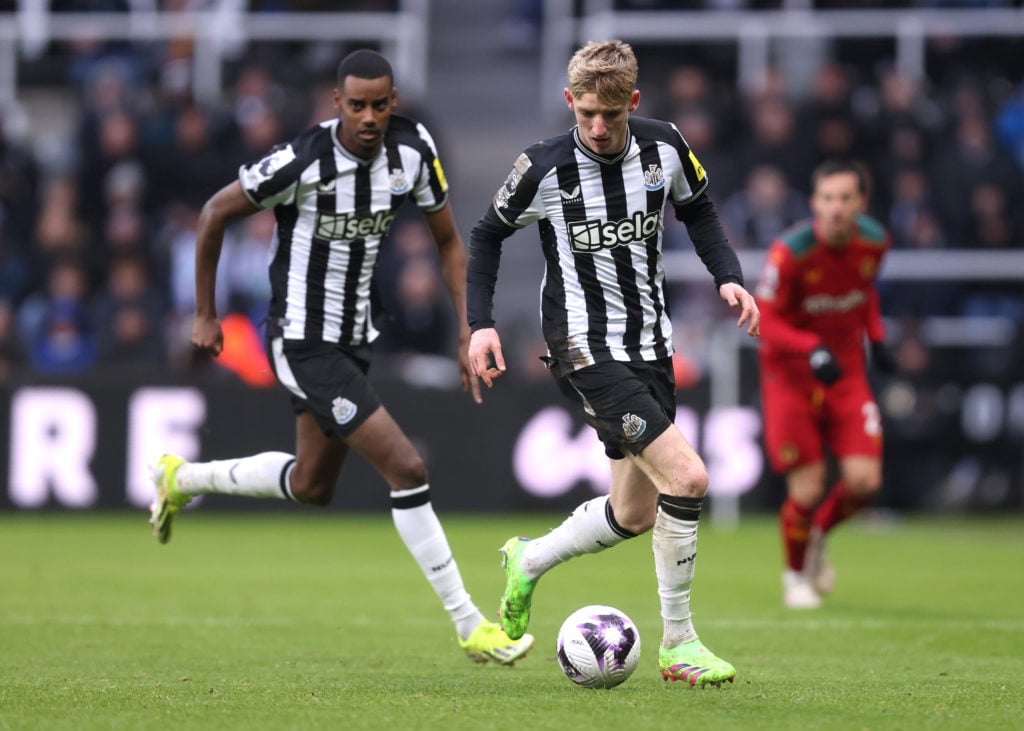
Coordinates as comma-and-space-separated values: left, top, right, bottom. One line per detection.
481, 117, 708, 373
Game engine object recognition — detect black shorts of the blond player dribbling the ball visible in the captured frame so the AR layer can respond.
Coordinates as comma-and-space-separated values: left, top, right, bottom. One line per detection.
557, 358, 676, 460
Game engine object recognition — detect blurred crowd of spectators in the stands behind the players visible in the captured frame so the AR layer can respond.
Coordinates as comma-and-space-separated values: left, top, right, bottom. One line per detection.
0, 0, 1024, 383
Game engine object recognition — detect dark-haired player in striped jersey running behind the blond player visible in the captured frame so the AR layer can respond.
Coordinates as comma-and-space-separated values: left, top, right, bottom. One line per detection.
151, 49, 534, 664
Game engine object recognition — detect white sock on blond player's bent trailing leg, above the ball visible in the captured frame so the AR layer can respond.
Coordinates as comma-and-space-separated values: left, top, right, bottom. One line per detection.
520, 496, 635, 578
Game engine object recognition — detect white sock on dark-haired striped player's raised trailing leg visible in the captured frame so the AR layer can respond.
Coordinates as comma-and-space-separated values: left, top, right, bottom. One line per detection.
175, 452, 295, 501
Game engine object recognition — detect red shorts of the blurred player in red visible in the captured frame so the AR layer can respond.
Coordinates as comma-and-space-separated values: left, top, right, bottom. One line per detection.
761, 362, 882, 472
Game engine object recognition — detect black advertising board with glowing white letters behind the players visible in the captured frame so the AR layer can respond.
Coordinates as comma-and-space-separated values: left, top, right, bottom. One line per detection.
0, 352, 1024, 511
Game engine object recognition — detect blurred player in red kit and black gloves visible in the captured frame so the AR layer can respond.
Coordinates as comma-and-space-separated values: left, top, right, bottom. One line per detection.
757, 161, 895, 609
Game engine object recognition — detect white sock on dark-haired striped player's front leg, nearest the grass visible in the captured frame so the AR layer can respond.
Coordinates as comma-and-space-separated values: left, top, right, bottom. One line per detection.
391, 485, 483, 640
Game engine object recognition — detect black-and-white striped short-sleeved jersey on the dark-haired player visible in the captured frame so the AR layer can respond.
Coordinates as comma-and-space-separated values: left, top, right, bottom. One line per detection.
239, 115, 447, 345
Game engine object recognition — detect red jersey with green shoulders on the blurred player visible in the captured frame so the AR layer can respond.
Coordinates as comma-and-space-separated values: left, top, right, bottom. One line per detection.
756, 215, 890, 377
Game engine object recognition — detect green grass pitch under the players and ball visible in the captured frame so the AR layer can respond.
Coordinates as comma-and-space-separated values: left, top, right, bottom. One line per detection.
0, 510, 1024, 731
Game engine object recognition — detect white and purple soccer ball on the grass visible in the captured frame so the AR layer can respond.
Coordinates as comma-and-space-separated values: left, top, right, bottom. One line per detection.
558, 604, 640, 688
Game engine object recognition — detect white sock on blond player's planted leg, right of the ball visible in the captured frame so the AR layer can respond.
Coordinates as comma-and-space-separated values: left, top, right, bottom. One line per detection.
651, 506, 697, 648
